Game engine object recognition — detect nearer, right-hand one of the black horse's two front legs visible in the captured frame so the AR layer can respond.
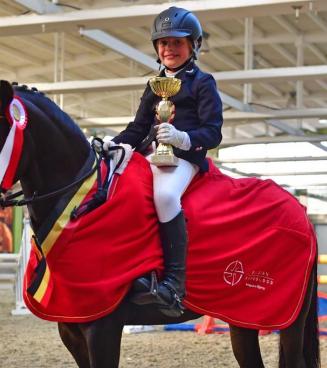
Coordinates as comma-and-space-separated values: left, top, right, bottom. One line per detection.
80, 315, 124, 368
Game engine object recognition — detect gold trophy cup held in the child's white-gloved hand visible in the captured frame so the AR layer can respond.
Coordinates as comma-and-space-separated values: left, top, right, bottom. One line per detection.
149, 77, 182, 166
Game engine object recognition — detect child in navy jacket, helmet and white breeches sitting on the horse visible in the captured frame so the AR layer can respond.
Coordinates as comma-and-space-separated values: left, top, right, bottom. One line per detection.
104, 7, 223, 316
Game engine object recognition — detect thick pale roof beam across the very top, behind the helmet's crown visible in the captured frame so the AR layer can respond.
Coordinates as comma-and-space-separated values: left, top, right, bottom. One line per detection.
0, 0, 327, 36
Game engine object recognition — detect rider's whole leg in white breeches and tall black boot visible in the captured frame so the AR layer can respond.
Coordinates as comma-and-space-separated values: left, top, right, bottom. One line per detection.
134, 159, 198, 316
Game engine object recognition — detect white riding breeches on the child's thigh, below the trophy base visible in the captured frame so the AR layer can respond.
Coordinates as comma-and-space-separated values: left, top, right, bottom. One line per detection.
147, 155, 199, 222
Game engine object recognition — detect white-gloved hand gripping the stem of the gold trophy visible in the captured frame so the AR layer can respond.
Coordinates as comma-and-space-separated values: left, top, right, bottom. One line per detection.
155, 123, 191, 151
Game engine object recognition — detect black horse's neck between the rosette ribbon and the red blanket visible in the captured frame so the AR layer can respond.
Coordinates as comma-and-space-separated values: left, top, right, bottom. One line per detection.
15, 92, 91, 231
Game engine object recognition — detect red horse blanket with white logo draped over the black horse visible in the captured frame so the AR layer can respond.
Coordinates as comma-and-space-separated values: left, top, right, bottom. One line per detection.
24, 154, 316, 329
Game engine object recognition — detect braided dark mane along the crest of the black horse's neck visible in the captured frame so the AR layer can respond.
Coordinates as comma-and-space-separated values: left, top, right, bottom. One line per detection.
13, 85, 86, 141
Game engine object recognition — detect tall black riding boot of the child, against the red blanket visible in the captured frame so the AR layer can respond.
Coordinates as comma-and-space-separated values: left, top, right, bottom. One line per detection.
131, 211, 187, 317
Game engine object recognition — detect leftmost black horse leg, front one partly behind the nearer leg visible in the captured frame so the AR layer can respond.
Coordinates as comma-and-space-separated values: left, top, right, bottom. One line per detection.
58, 323, 90, 368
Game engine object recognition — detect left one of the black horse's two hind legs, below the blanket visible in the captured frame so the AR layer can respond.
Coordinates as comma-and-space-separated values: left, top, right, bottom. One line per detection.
229, 325, 264, 368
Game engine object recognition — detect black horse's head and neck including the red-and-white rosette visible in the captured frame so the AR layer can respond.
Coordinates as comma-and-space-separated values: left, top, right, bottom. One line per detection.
0, 81, 93, 230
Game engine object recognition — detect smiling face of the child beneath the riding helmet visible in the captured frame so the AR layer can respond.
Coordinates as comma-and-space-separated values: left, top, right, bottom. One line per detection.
157, 37, 192, 69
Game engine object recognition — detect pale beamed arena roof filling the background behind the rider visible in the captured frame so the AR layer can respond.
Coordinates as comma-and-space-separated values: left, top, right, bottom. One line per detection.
0, 0, 327, 207
